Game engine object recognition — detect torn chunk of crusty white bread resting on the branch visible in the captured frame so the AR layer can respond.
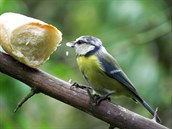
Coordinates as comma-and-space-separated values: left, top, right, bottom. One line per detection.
0, 12, 62, 68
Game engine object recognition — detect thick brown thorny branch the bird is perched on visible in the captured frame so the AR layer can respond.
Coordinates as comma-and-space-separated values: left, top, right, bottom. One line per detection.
0, 52, 167, 129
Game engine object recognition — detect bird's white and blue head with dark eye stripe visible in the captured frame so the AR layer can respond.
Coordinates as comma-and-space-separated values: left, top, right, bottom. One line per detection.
66, 36, 102, 56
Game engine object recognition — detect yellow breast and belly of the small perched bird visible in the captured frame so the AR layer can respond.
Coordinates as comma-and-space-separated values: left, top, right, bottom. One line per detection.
77, 55, 129, 95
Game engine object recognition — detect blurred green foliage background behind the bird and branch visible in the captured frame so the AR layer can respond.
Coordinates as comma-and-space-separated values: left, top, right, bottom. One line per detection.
0, 0, 172, 129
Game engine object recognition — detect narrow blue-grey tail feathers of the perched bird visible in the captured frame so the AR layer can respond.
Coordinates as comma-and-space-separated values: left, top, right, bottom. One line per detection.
139, 100, 161, 123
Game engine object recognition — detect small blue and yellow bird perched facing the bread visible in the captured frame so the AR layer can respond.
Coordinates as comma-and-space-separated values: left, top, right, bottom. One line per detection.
66, 36, 159, 120
